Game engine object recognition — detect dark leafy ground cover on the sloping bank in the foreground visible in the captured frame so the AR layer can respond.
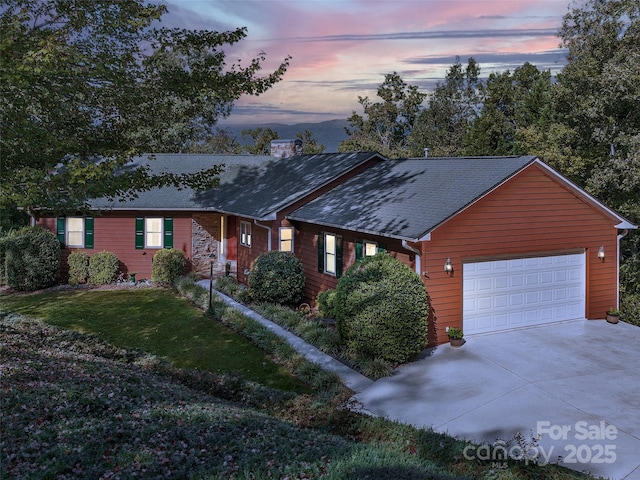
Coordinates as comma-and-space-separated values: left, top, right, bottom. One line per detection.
0, 314, 586, 480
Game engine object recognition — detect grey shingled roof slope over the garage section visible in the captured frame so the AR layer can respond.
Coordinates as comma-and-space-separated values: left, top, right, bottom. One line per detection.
287, 156, 536, 241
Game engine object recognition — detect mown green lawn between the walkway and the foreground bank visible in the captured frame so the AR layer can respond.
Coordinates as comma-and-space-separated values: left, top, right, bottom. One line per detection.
0, 288, 309, 393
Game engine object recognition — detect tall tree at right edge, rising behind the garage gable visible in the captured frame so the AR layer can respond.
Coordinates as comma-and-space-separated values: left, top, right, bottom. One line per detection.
552, 0, 640, 324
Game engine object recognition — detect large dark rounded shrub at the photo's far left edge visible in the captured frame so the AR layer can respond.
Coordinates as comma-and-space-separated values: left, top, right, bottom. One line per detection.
2, 227, 60, 291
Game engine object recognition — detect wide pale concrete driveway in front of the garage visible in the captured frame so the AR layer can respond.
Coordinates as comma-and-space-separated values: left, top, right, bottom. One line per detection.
356, 320, 640, 480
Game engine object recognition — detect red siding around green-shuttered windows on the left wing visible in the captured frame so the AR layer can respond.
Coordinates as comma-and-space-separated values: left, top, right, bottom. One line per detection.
38, 211, 192, 280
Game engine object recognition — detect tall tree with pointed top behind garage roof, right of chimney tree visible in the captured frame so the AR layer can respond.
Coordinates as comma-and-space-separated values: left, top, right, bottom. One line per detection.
409, 57, 482, 156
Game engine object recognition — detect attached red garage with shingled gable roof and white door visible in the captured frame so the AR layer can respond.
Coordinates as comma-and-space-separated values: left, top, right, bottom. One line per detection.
287, 157, 636, 345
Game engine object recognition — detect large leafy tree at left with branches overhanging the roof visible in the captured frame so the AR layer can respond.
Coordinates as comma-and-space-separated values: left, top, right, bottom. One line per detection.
0, 0, 289, 214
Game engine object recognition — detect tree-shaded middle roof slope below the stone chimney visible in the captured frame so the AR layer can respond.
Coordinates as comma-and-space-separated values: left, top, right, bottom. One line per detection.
195, 152, 384, 220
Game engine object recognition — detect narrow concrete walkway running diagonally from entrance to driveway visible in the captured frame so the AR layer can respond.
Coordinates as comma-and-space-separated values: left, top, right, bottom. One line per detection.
198, 280, 373, 393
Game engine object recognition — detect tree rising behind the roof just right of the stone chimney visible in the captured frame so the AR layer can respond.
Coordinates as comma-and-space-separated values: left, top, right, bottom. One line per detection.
338, 72, 426, 157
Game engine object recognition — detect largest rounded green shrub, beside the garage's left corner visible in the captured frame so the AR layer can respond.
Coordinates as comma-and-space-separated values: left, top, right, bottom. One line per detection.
335, 253, 429, 363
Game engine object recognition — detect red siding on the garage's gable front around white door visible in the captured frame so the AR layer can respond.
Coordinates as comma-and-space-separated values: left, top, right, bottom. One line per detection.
422, 165, 617, 344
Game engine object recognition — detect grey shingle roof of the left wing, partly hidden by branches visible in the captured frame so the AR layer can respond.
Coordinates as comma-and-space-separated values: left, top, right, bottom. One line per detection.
89, 153, 274, 210
